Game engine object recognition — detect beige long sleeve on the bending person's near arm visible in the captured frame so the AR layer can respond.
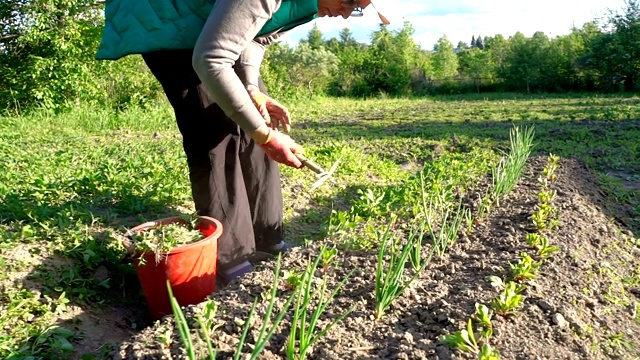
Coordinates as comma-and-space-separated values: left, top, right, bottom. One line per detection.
193, 0, 282, 133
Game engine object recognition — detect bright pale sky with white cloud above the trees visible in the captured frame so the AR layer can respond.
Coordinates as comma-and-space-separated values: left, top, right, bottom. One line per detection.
283, 0, 624, 49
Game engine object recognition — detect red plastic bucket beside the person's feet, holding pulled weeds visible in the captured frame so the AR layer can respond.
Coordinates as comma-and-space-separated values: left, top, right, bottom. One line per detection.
129, 216, 222, 320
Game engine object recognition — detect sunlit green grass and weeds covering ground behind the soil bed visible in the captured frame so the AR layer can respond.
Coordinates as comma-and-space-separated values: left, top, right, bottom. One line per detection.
0, 94, 640, 358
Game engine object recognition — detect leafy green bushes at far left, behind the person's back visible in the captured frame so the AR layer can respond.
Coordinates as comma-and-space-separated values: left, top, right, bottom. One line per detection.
0, 0, 159, 111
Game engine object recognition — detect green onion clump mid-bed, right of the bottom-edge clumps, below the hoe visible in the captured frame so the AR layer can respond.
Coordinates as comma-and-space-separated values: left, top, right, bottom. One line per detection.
374, 216, 429, 320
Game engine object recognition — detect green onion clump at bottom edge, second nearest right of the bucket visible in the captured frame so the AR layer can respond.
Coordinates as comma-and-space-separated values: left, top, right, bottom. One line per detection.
286, 248, 352, 360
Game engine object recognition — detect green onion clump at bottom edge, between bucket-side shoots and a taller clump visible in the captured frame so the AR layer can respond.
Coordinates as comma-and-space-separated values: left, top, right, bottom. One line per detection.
233, 254, 295, 360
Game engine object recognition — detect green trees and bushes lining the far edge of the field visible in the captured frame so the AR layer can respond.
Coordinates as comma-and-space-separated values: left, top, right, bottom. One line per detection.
0, 0, 640, 111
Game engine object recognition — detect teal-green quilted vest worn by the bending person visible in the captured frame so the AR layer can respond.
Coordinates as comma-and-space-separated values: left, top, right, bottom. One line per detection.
96, 0, 318, 60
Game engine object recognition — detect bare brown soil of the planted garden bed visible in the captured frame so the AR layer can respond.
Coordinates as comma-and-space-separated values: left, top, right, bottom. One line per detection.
96, 157, 640, 359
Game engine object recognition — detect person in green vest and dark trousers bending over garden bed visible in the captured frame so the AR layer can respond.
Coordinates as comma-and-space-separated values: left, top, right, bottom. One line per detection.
97, 0, 386, 282
